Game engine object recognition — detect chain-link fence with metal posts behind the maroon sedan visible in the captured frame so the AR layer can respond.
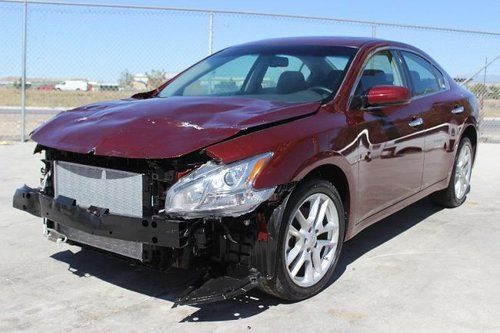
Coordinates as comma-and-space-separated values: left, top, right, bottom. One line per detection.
0, 0, 500, 142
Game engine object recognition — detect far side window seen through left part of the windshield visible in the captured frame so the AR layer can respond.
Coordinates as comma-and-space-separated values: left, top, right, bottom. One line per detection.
183, 55, 257, 96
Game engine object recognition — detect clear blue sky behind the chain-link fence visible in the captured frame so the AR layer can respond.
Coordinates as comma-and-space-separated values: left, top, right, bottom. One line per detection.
0, 0, 500, 82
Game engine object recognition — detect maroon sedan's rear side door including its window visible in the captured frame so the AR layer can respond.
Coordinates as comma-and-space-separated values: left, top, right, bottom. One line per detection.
400, 51, 463, 188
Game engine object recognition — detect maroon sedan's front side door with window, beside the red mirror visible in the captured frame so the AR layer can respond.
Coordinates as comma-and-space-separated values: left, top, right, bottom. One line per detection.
352, 50, 424, 220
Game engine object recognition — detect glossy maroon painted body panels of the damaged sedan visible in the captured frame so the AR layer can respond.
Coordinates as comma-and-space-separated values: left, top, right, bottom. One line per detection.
32, 38, 477, 239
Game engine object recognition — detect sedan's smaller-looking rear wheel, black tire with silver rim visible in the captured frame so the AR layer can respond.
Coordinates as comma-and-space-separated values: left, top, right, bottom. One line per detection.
431, 137, 474, 208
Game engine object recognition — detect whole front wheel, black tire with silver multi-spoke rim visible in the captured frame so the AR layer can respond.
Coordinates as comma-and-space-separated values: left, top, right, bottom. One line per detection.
260, 179, 345, 301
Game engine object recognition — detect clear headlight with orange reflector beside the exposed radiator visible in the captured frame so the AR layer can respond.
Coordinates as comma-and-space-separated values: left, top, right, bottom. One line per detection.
165, 153, 276, 218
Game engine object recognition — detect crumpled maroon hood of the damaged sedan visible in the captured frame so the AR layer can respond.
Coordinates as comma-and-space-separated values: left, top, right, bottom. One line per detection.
31, 97, 320, 159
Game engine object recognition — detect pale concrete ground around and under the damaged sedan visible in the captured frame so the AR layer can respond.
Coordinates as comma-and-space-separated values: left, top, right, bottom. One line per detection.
0, 144, 500, 332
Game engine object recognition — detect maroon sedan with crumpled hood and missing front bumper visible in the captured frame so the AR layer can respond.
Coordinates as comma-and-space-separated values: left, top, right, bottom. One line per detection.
13, 37, 478, 304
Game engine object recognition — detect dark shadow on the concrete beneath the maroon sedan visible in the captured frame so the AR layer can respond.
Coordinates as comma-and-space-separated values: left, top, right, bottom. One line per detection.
51, 199, 442, 322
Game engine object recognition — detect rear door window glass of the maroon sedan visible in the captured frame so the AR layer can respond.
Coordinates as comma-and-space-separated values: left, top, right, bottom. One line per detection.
401, 51, 446, 96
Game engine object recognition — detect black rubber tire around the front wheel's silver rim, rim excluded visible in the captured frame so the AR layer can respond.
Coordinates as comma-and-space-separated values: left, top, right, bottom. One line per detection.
260, 179, 346, 301
